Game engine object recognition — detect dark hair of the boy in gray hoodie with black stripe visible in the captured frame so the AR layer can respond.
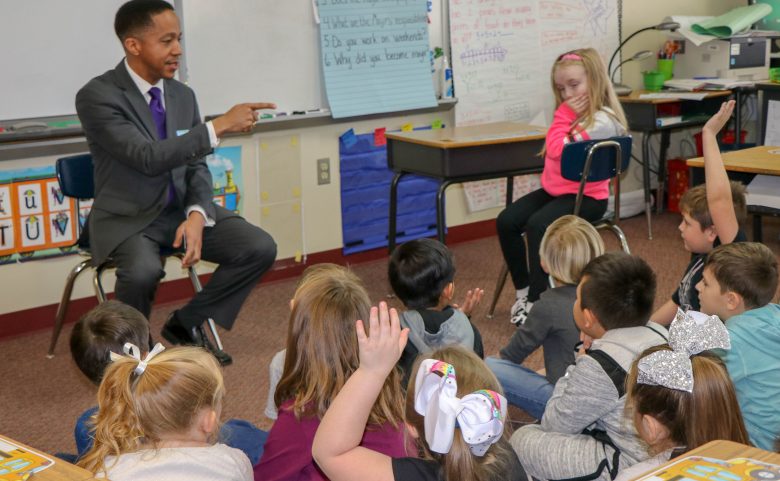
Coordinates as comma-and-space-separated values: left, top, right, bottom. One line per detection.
580, 251, 655, 331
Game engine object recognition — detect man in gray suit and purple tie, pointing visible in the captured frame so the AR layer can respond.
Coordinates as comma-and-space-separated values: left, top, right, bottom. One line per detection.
76, 0, 276, 364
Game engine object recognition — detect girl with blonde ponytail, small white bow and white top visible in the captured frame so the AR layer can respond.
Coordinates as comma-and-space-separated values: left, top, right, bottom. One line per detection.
79, 343, 252, 481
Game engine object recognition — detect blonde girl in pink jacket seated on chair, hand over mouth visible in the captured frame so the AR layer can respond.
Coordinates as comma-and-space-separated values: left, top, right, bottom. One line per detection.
496, 48, 628, 324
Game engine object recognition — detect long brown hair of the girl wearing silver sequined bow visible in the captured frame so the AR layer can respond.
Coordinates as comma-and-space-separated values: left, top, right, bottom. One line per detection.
626, 344, 750, 450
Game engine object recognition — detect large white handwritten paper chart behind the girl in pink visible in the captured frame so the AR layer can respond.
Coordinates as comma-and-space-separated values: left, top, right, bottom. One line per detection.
450, 0, 620, 125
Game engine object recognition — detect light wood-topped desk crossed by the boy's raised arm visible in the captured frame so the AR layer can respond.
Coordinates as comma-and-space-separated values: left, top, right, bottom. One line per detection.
687, 145, 780, 242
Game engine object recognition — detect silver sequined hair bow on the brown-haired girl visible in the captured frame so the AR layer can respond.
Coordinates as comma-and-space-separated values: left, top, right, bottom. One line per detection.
636, 309, 731, 392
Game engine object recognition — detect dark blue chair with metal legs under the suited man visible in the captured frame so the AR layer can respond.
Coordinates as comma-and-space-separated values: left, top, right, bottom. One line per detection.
46, 154, 222, 358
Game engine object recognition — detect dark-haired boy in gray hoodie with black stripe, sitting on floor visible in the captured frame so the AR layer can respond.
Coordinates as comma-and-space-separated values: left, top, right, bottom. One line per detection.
511, 252, 667, 480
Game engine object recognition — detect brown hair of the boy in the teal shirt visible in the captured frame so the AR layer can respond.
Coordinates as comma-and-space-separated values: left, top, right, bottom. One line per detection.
704, 242, 777, 309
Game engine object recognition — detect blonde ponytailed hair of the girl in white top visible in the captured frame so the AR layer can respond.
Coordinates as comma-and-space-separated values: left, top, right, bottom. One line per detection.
78, 347, 225, 473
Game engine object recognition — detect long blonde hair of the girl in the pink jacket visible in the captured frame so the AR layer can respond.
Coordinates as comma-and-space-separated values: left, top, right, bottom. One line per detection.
550, 48, 628, 129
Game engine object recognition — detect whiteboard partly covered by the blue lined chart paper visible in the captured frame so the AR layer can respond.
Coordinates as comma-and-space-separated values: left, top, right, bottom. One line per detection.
176, 0, 442, 115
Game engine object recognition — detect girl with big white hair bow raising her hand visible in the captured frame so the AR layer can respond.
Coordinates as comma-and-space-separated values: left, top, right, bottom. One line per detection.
312, 303, 527, 481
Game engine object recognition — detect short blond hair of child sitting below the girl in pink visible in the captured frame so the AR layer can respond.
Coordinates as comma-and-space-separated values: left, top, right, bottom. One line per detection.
539, 215, 604, 285
